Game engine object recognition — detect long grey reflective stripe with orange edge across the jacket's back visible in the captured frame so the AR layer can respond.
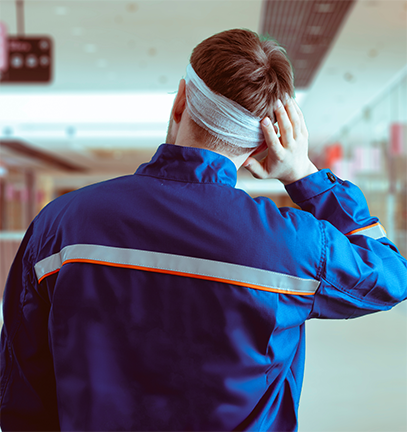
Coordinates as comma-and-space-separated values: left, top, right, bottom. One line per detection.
35, 244, 320, 295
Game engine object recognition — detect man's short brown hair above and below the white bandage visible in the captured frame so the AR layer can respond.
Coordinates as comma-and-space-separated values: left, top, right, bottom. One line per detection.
190, 29, 294, 155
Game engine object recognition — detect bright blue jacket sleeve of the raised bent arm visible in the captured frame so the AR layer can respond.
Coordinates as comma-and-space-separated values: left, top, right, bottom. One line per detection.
286, 170, 407, 318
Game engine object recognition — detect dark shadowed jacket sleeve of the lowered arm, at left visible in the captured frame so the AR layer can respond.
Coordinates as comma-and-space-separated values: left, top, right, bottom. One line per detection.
0, 226, 60, 432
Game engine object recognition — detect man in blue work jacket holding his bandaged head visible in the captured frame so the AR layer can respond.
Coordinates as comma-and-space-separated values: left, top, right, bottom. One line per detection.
0, 30, 407, 432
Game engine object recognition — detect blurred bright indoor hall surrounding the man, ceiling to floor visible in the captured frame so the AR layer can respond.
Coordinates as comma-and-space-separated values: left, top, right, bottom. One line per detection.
0, 0, 407, 432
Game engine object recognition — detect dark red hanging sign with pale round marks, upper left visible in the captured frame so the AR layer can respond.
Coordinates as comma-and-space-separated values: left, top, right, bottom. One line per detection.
0, 36, 52, 84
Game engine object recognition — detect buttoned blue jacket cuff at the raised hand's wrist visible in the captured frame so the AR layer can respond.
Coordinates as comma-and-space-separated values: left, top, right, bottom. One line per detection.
285, 169, 342, 205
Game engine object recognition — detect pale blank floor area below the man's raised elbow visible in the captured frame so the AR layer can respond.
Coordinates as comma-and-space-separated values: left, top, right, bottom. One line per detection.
299, 302, 407, 432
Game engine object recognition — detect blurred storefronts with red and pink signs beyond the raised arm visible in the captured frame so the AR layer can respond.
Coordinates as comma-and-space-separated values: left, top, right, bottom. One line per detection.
311, 69, 407, 256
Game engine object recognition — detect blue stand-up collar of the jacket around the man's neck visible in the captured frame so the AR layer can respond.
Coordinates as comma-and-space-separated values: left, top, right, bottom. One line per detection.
136, 144, 237, 187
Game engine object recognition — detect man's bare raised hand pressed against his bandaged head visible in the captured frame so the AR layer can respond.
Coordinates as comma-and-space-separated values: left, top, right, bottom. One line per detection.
243, 95, 318, 185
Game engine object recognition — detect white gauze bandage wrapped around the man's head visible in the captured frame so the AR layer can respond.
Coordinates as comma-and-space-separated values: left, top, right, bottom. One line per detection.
185, 64, 264, 148
